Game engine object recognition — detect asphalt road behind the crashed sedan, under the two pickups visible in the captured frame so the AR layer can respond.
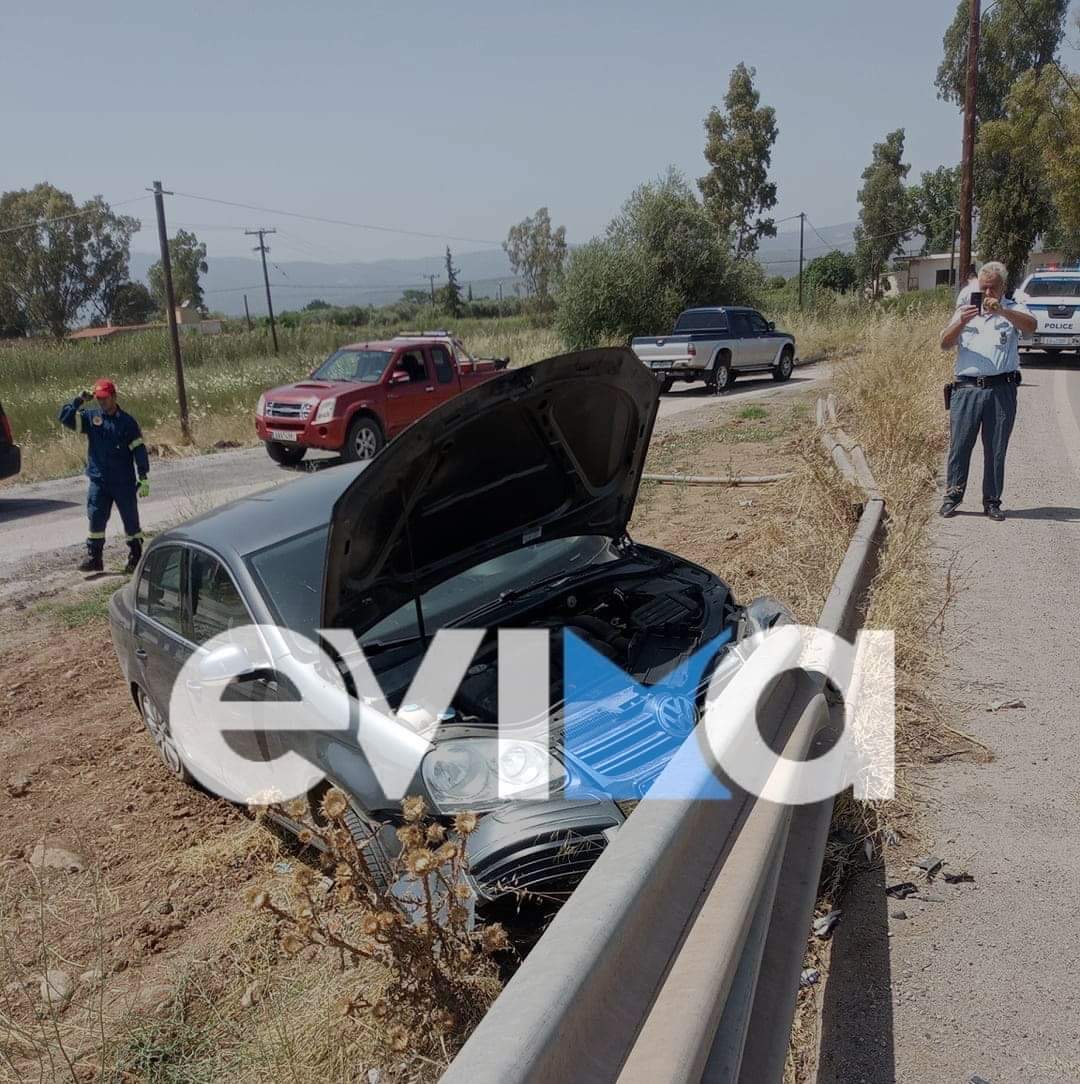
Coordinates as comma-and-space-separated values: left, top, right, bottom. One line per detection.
0, 364, 823, 603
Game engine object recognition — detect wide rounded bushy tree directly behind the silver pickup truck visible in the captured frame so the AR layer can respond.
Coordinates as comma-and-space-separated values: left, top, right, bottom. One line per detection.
555, 170, 764, 349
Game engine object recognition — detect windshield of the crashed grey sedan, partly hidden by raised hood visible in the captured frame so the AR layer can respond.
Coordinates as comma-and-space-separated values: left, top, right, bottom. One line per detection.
247, 527, 615, 643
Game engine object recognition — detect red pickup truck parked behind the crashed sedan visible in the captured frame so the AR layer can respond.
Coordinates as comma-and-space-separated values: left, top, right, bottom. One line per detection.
255, 332, 510, 466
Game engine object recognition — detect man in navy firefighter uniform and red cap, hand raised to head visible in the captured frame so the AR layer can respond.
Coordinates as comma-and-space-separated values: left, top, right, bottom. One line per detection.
60, 379, 150, 572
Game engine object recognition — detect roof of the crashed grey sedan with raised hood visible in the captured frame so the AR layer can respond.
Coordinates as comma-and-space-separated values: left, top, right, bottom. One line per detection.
155, 460, 371, 557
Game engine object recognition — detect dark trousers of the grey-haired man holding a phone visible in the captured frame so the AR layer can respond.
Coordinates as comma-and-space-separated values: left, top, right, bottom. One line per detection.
946, 384, 1016, 504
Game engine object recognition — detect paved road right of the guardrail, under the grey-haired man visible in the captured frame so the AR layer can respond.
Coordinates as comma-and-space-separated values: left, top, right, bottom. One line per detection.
818, 362, 1080, 1084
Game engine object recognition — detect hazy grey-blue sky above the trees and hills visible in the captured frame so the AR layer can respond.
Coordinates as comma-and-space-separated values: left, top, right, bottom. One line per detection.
0, 0, 1080, 260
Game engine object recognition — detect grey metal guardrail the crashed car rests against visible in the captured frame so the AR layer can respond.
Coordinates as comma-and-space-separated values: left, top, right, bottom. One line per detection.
442, 405, 885, 1084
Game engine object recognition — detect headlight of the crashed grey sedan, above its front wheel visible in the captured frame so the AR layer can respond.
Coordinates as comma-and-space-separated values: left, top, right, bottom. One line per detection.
421, 738, 566, 813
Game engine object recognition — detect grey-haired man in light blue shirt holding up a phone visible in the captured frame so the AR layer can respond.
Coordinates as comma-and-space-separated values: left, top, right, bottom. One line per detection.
940, 261, 1037, 521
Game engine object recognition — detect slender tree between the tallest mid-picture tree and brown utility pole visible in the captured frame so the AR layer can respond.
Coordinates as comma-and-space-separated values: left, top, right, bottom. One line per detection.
854, 128, 911, 295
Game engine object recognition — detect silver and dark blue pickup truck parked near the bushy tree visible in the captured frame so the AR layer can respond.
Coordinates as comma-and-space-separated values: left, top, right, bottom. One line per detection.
630, 306, 798, 392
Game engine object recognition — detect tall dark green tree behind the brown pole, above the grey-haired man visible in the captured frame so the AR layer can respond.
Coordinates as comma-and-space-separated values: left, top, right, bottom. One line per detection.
936, 0, 1069, 285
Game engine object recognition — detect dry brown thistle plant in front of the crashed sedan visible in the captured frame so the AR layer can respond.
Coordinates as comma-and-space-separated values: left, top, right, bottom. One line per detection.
247, 787, 510, 1059
